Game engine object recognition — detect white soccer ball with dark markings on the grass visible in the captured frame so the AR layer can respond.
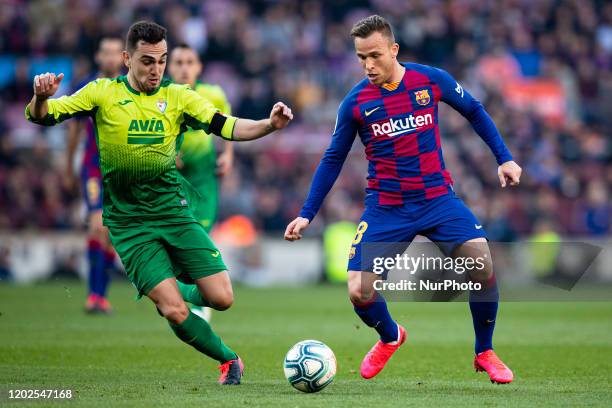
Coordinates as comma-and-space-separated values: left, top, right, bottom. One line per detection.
284, 340, 336, 392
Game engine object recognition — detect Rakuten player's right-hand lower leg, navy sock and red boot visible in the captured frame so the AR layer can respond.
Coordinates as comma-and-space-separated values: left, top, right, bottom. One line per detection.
453, 238, 514, 383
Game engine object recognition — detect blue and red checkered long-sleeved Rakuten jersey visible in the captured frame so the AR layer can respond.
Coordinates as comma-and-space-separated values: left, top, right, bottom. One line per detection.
300, 63, 512, 220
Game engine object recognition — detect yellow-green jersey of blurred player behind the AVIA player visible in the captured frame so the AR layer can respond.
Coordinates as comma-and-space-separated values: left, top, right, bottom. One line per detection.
179, 82, 232, 185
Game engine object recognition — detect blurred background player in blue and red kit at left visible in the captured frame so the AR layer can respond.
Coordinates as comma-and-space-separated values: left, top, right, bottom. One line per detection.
66, 37, 123, 313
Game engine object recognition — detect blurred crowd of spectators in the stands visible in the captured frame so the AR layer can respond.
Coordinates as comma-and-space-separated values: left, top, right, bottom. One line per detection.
0, 0, 612, 241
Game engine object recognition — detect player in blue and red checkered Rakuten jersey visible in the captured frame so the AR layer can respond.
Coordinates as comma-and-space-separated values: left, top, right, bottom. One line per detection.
285, 16, 521, 383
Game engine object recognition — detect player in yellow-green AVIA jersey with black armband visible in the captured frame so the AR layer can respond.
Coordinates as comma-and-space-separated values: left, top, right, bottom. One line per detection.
25, 22, 293, 384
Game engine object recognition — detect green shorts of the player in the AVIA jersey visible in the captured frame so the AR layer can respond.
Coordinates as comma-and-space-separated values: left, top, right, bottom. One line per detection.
109, 221, 227, 297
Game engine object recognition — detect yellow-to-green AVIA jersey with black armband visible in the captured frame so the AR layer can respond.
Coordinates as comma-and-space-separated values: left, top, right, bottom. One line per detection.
25, 76, 236, 226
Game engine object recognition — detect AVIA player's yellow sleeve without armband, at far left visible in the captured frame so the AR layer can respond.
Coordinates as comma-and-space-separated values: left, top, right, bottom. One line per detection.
25, 79, 100, 126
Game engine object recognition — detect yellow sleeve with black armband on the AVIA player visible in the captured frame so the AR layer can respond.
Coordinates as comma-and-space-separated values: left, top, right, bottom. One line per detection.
181, 87, 238, 140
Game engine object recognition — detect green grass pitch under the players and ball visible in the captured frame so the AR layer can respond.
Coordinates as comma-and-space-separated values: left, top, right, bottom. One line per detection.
0, 282, 612, 408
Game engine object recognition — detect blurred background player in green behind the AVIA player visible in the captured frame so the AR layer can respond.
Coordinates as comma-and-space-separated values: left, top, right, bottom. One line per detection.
168, 44, 234, 321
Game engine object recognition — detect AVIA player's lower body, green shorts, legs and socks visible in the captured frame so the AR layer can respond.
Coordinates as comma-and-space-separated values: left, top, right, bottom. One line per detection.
110, 222, 241, 384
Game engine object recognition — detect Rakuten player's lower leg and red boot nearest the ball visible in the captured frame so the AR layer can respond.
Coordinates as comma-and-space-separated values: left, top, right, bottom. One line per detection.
348, 271, 406, 379
